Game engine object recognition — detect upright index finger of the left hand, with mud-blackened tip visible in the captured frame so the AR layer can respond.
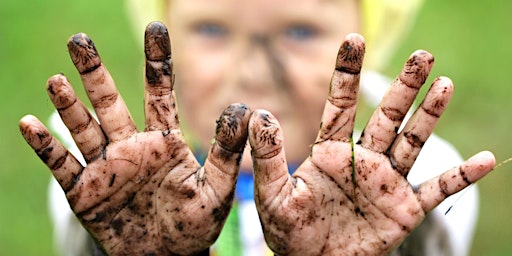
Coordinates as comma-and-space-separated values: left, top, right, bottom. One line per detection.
144, 22, 178, 131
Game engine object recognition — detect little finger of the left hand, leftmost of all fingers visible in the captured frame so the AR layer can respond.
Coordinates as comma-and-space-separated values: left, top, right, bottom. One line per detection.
19, 115, 84, 192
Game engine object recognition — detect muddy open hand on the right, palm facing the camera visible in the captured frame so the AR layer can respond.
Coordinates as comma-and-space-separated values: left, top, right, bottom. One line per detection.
249, 34, 495, 255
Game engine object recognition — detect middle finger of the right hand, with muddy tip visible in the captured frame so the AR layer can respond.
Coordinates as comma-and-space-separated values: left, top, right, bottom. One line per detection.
358, 50, 434, 153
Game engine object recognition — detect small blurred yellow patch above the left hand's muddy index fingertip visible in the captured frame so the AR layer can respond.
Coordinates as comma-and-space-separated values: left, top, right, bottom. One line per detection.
126, 0, 170, 43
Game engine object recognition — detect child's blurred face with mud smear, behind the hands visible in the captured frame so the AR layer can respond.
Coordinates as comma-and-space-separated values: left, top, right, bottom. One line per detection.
167, 0, 360, 162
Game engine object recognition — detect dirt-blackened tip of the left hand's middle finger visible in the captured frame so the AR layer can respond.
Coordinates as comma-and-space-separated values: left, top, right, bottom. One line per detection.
68, 33, 101, 74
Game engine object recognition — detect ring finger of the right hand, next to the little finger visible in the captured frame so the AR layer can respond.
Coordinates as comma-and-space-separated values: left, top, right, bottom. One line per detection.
389, 77, 453, 176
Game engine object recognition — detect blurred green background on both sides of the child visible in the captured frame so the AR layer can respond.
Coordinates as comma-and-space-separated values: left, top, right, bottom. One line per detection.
0, 0, 512, 255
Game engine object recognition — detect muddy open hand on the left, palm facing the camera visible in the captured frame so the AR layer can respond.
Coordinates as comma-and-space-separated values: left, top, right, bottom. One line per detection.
20, 23, 250, 255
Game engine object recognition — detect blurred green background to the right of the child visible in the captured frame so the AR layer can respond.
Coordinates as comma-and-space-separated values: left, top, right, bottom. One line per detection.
387, 0, 512, 255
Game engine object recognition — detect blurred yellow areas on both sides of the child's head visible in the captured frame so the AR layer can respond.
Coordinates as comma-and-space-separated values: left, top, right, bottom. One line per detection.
127, 0, 423, 71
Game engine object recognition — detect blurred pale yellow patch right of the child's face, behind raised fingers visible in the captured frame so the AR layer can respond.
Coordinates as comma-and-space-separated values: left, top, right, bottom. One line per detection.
361, 0, 423, 71
